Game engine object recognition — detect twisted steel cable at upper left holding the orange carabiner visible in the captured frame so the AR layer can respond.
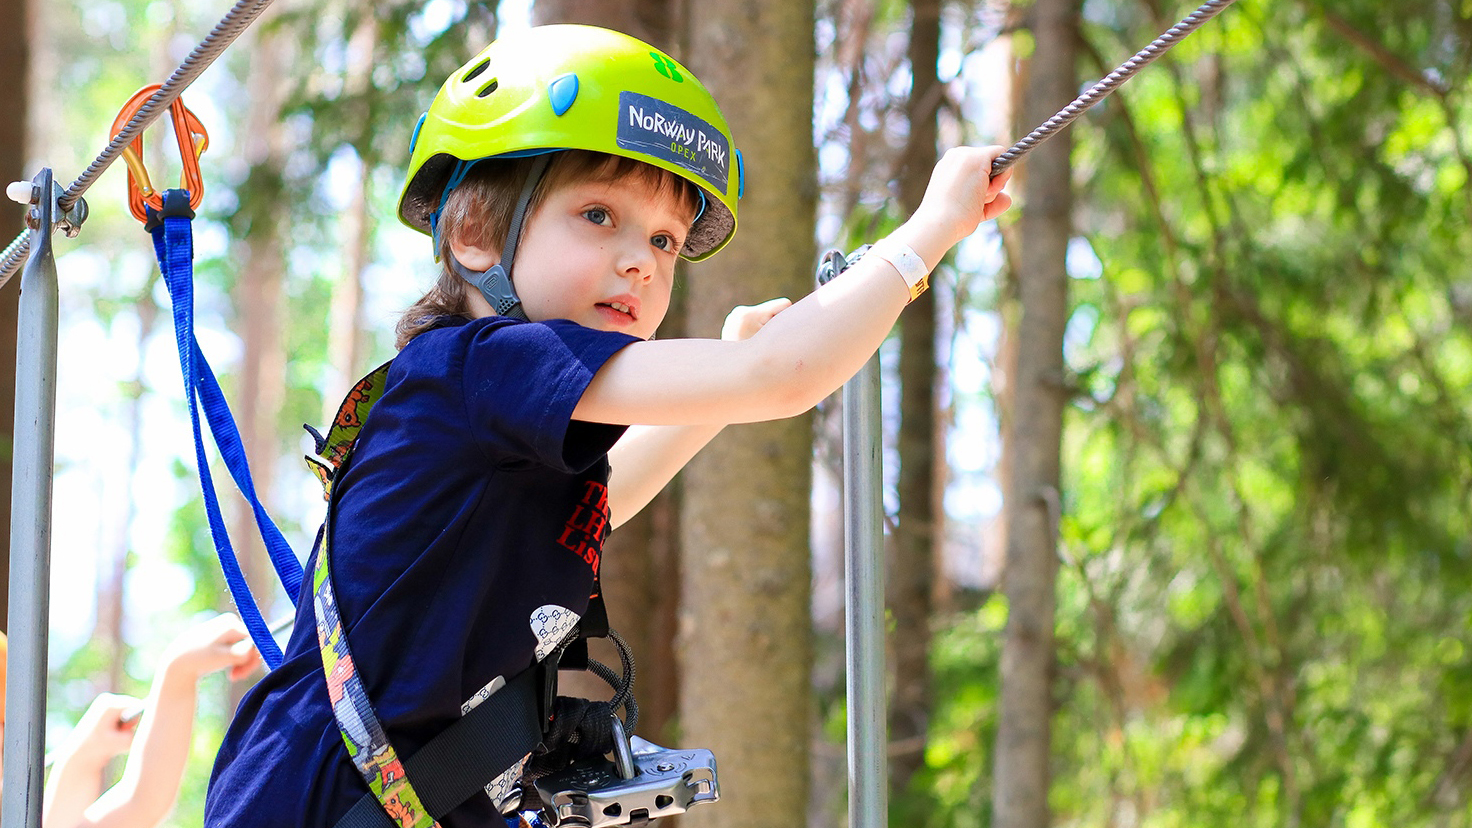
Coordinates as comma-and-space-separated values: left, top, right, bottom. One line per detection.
0, 0, 271, 287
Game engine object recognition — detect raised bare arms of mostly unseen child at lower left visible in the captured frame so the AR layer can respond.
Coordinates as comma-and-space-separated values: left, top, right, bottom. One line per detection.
0, 614, 261, 828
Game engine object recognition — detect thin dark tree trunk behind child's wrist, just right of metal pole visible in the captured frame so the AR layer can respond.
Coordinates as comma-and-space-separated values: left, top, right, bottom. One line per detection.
888, 0, 945, 793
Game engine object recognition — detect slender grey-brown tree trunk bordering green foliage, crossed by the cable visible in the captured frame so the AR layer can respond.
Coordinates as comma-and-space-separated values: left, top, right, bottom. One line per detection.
992, 0, 1082, 828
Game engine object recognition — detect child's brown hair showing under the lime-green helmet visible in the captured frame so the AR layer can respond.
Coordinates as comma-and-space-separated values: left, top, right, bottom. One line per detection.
394, 150, 701, 349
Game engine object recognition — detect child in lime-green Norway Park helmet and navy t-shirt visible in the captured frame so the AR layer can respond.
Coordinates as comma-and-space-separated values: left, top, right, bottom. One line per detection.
206, 27, 1010, 827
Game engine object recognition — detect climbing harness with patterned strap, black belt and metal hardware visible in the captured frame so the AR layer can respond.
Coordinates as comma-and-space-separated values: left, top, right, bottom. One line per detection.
306, 361, 720, 828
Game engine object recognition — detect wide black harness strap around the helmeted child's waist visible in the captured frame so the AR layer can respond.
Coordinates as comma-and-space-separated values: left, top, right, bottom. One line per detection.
336, 664, 543, 828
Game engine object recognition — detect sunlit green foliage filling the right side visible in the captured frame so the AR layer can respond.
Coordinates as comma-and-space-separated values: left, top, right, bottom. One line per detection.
1018, 1, 1472, 825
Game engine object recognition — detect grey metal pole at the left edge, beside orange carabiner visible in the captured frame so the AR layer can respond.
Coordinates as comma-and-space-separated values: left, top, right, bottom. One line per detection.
0, 168, 60, 828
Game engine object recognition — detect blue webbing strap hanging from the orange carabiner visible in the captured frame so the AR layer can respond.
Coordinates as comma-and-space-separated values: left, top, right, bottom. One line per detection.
147, 190, 302, 669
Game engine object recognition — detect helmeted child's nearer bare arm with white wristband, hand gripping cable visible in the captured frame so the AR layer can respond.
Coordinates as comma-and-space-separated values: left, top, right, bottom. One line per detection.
574, 147, 1011, 426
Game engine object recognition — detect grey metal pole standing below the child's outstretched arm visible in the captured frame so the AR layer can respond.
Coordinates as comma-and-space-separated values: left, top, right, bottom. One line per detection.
843, 357, 889, 828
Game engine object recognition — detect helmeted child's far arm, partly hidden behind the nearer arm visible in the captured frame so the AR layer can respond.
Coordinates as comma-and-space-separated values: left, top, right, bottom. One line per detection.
608, 299, 792, 526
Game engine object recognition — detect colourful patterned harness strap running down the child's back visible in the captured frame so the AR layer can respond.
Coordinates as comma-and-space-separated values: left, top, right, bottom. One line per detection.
306, 361, 439, 828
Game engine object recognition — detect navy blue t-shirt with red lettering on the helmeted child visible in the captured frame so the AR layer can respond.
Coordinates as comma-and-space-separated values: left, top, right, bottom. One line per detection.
205, 317, 636, 828
